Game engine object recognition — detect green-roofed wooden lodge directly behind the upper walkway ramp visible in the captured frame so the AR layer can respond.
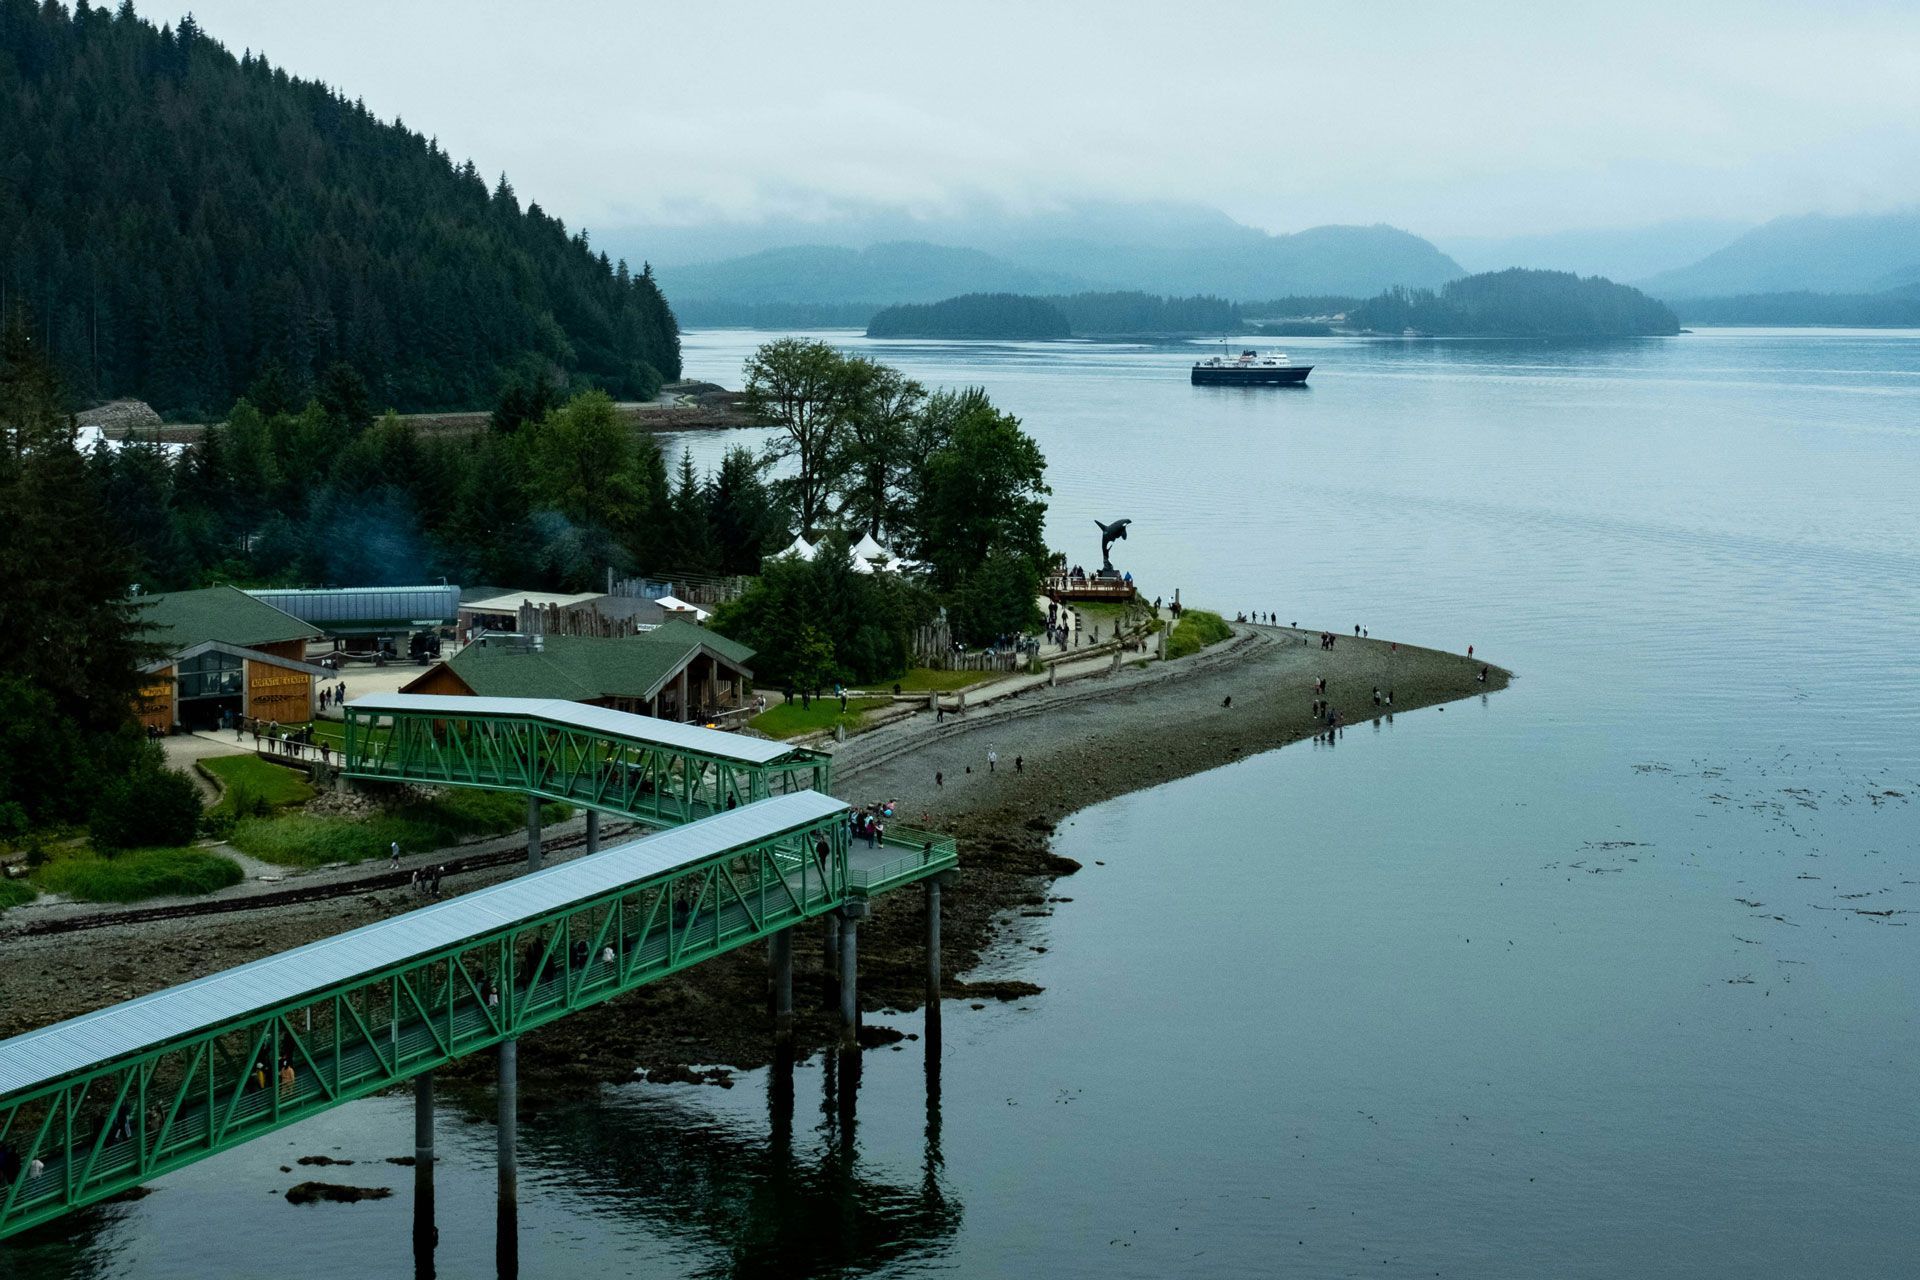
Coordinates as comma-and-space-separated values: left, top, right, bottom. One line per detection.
401, 622, 753, 722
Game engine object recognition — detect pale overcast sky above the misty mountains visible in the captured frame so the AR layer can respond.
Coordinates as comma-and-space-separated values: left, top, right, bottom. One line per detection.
180, 0, 1920, 236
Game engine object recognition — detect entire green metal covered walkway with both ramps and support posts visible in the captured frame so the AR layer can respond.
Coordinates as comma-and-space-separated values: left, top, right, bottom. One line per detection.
0, 699, 956, 1240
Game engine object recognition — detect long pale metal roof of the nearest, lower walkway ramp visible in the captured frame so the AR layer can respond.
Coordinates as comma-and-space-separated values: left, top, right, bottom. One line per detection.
0, 790, 847, 1096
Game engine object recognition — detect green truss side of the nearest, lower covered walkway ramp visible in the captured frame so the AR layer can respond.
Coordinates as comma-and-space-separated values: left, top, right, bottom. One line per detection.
0, 816, 851, 1238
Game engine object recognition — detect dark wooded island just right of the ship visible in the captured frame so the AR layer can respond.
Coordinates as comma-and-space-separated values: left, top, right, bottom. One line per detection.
1344, 267, 1680, 338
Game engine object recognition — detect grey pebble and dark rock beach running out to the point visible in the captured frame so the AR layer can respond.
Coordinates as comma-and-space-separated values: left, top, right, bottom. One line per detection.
0, 626, 1509, 1090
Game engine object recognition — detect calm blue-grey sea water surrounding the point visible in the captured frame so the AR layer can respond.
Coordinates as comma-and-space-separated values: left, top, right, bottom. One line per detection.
15, 330, 1920, 1276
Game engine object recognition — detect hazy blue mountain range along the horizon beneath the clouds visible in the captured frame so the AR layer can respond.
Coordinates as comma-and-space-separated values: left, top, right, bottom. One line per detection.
597, 203, 1920, 318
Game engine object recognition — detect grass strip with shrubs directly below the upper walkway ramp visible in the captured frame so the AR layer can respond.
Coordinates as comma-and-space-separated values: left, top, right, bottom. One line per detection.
232, 791, 574, 867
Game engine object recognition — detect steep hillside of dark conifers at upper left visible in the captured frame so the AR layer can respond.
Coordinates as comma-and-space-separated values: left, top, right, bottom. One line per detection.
0, 0, 680, 416
